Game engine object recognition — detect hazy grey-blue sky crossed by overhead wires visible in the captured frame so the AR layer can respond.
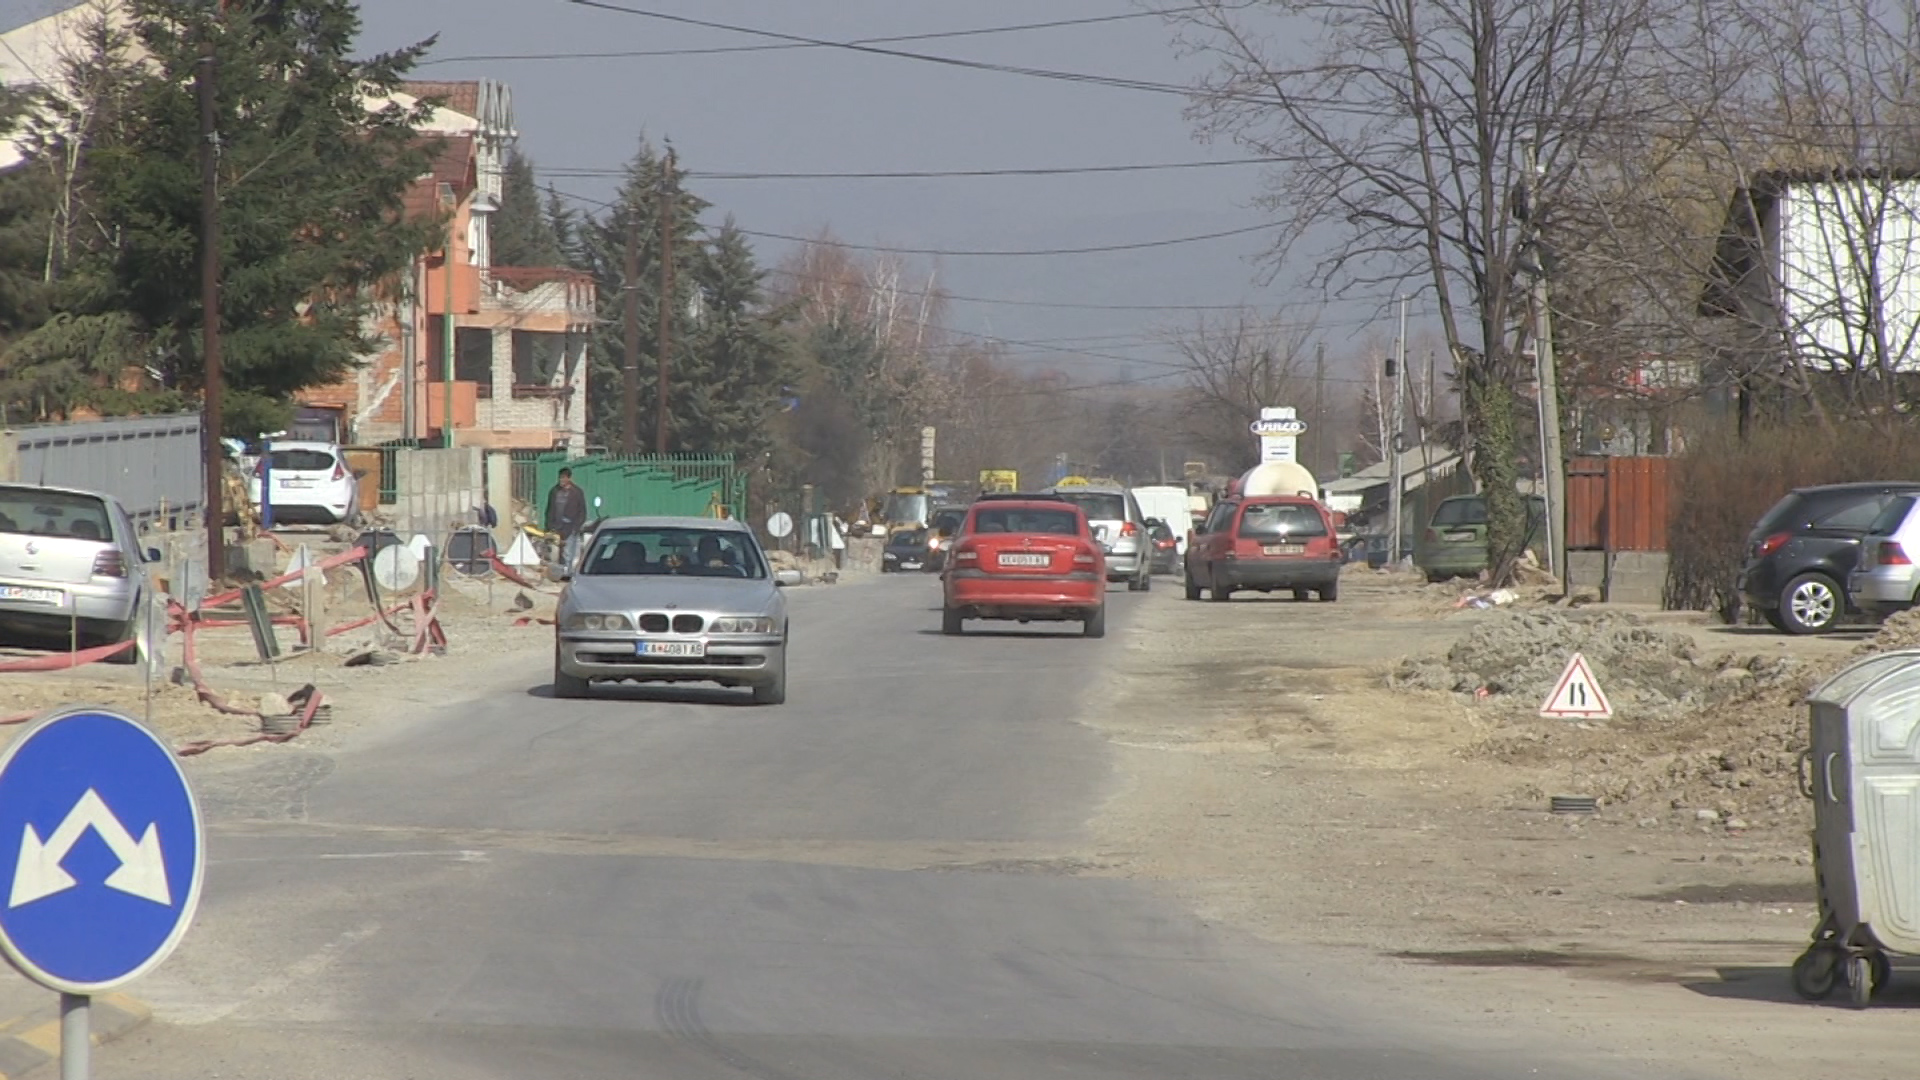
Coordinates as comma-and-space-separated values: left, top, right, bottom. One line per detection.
345, 0, 1346, 386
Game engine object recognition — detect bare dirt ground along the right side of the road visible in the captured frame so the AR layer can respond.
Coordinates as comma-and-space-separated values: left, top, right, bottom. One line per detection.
1087, 569, 1920, 1078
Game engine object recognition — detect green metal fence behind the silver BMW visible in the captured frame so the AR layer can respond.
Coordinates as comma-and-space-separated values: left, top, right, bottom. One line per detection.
513, 452, 747, 519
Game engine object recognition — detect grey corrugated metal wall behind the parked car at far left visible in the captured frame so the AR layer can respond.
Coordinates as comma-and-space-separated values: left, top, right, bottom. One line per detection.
15, 415, 205, 523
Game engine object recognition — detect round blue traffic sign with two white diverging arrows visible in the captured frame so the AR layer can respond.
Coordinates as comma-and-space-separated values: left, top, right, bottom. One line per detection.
0, 707, 205, 994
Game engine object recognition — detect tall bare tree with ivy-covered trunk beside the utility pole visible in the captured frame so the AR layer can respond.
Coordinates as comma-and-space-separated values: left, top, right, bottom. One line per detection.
1179, 0, 1659, 577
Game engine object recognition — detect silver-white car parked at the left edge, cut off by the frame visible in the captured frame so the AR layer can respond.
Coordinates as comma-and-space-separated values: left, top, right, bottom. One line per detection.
0, 484, 159, 663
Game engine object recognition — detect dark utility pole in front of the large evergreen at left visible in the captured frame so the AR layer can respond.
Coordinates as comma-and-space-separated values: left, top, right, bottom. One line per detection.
194, 18, 225, 584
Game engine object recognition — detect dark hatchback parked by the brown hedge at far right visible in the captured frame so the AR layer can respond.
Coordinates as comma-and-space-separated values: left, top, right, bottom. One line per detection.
1740, 480, 1920, 634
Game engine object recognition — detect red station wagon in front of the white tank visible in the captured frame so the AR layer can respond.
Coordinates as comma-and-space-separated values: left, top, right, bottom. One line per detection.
1187, 496, 1344, 601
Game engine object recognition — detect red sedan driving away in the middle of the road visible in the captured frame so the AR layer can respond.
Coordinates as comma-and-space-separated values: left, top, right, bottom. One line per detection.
941, 496, 1106, 638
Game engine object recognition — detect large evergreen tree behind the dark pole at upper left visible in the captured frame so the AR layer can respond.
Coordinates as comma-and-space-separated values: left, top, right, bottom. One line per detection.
13, 0, 440, 436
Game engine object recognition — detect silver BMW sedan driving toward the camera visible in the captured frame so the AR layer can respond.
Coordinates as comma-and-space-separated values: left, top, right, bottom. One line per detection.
553, 517, 787, 705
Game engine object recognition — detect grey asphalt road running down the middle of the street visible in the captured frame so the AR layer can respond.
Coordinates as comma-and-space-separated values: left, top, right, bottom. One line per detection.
94, 577, 1674, 1080
